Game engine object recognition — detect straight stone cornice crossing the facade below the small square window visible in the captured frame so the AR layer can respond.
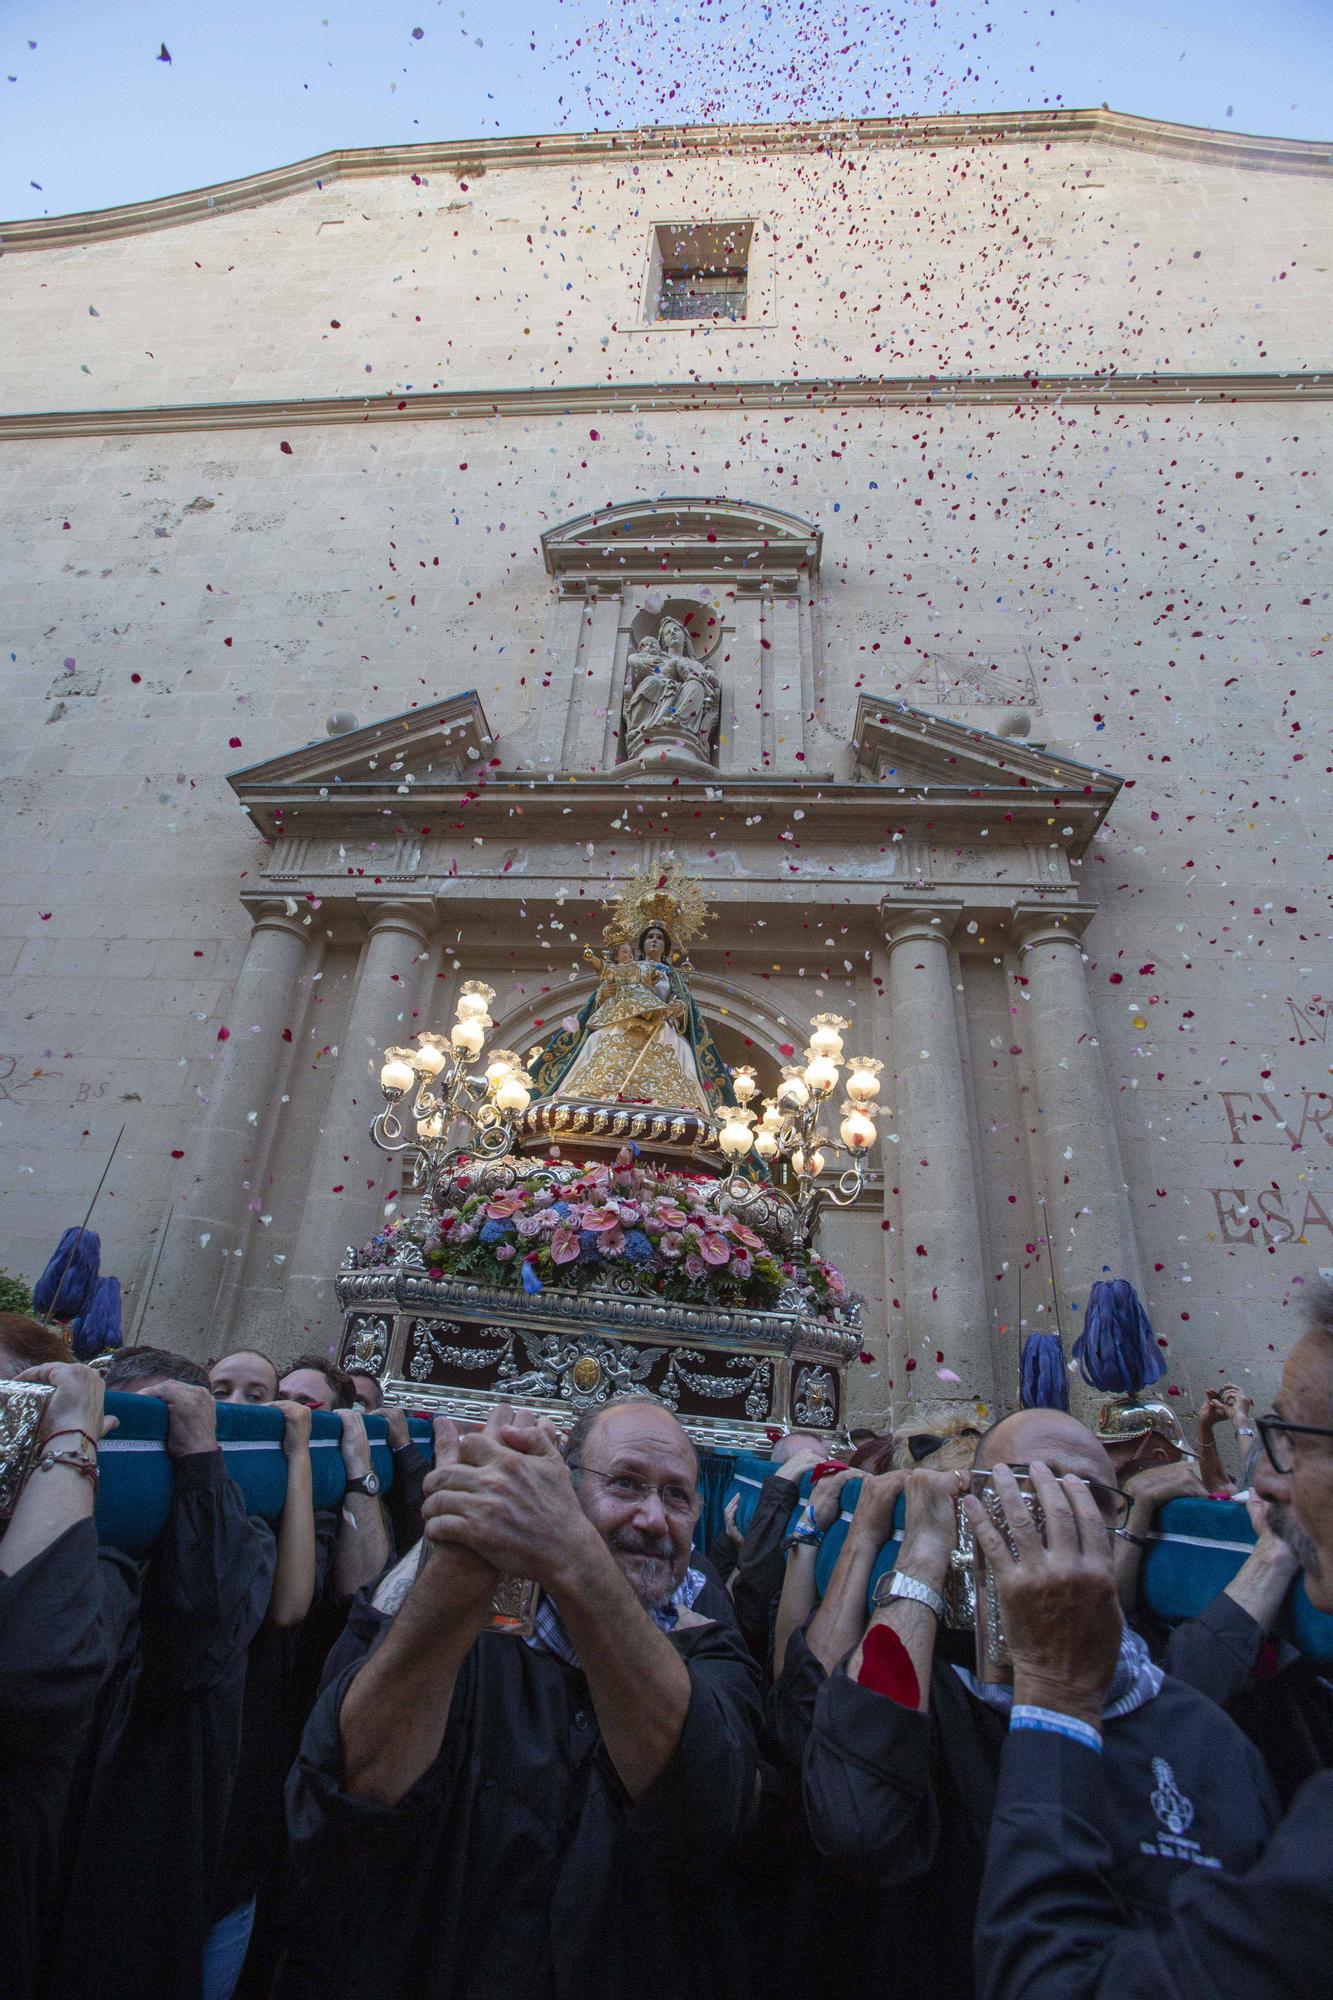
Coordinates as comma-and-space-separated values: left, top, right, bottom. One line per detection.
0, 370, 1333, 444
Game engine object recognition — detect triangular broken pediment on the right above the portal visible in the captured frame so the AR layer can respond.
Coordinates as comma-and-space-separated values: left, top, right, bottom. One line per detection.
853, 694, 1123, 812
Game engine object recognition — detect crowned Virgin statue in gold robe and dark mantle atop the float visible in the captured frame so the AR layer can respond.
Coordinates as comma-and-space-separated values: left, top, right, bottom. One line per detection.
530, 868, 735, 1114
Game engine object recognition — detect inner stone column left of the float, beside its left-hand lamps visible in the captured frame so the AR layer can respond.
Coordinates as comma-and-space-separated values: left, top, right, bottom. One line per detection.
286, 896, 434, 1348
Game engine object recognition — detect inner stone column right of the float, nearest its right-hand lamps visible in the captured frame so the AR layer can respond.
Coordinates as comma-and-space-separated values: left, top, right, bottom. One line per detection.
881, 904, 995, 1406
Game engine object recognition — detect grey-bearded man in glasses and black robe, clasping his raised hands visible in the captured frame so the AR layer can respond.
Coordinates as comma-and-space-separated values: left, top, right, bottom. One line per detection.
278, 1398, 761, 2000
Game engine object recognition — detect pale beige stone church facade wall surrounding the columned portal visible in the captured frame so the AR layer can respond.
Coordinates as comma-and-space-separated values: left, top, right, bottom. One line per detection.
0, 117, 1333, 1414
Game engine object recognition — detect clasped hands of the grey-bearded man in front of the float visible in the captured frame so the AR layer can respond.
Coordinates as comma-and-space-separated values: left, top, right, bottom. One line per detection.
422, 1404, 602, 1596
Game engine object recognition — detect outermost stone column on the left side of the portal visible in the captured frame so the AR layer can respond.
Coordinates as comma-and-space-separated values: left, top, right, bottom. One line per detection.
140, 900, 310, 1360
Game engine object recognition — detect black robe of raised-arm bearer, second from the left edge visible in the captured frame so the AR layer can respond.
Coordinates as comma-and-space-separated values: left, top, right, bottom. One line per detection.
48, 1450, 274, 2000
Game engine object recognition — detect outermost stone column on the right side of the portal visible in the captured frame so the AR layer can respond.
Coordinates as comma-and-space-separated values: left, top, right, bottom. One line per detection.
1013, 904, 1143, 1312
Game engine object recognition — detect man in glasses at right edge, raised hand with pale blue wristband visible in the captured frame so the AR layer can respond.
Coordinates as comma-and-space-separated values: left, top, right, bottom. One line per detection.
965, 1286, 1333, 2000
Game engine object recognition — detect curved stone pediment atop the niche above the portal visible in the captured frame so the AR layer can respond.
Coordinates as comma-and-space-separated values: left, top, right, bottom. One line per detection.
542, 496, 823, 588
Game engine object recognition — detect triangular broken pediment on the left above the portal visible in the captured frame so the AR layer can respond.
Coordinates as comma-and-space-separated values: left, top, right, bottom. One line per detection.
226, 688, 492, 814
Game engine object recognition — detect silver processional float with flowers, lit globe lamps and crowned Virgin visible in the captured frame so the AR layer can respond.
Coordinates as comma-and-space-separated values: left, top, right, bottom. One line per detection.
336, 864, 881, 1448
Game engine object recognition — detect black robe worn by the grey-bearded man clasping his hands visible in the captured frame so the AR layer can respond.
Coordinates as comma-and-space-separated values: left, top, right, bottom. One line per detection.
278, 1622, 761, 2000
